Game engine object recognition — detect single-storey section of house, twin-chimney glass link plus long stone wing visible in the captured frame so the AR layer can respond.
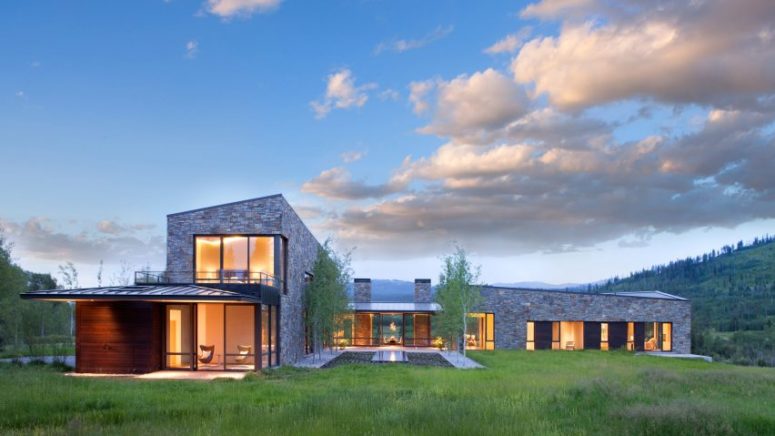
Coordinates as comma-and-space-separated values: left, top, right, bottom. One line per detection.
338, 278, 691, 353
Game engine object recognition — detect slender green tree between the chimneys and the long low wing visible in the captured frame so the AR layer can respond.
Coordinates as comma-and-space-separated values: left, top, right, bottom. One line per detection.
434, 246, 483, 356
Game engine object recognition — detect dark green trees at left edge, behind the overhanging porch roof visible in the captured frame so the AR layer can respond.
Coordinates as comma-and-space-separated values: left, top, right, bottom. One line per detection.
0, 232, 72, 356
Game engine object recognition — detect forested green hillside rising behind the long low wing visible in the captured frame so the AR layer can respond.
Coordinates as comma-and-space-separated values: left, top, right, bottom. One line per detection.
590, 236, 775, 366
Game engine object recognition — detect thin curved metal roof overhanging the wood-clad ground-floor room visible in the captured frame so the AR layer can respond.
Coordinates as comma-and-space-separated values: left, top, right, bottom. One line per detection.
21, 285, 259, 303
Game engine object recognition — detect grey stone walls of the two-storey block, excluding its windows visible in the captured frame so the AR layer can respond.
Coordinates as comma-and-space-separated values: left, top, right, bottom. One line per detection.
167, 194, 320, 363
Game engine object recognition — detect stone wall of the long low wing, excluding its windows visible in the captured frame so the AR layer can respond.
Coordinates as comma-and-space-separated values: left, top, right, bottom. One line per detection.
478, 286, 691, 353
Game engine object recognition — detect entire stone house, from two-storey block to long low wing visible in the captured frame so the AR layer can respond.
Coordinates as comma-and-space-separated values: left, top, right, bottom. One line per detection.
22, 195, 691, 373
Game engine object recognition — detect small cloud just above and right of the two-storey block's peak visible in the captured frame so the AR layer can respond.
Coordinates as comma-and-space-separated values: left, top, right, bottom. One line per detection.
301, 167, 405, 200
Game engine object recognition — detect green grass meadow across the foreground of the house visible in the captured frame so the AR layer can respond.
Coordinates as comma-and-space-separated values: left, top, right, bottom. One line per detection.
0, 351, 775, 435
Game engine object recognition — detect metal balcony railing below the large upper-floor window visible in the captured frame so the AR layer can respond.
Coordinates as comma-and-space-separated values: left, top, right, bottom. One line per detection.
135, 269, 283, 289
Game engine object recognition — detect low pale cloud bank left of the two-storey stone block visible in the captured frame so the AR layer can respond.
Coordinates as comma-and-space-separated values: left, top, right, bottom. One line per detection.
0, 217, 165, 264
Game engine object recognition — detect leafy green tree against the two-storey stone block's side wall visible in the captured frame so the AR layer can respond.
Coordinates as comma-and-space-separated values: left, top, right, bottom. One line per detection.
304, 239, 351, 354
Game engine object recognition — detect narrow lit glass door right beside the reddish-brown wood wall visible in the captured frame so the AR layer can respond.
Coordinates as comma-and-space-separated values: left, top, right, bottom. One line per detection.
164, 304, 196, 369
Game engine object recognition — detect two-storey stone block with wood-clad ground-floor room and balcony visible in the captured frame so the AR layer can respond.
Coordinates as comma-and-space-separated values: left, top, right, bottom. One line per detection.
22, 195, 320, 373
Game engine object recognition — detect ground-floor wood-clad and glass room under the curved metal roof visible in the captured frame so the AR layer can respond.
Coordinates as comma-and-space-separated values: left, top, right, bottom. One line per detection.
24, 285, 280, 374
